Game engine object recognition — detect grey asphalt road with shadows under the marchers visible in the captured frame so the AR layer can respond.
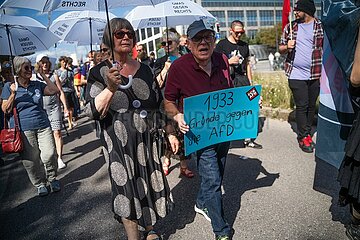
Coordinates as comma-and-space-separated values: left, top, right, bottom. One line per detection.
0, 118, 349, 240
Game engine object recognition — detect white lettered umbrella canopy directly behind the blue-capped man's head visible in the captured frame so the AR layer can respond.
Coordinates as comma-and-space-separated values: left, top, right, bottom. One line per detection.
125, 0, 216, 29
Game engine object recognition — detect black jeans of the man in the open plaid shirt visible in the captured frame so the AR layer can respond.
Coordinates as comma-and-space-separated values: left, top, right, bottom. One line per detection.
289, 79, 320, 139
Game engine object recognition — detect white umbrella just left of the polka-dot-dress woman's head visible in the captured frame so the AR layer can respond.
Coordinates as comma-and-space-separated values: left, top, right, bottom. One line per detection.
50, 11, 115, 50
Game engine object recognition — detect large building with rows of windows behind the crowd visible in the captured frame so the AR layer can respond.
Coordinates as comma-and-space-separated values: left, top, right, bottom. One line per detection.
136, 0, 321, 57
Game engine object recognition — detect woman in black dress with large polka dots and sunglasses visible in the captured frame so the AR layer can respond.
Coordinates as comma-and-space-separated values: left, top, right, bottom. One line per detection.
86, 18, 179, 239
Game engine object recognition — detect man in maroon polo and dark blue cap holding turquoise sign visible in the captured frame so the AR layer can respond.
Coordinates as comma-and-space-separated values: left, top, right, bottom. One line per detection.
165, 20, 233, 239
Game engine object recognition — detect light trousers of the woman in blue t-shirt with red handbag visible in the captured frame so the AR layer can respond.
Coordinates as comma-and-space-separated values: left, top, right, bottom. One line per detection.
21, 127, 57, 187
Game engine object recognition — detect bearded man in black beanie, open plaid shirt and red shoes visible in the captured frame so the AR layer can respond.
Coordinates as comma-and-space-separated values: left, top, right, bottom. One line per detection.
279, 0, 324, 153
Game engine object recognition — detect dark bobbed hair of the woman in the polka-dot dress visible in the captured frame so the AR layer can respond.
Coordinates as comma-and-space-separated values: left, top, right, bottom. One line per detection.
103, 18, 136, 47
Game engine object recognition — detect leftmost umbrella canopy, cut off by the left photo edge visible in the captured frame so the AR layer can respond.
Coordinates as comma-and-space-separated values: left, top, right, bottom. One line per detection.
0, 14, 59, 56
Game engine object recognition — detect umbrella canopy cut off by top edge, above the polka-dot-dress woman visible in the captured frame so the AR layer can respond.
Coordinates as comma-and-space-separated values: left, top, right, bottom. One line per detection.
0, 0, 170, 12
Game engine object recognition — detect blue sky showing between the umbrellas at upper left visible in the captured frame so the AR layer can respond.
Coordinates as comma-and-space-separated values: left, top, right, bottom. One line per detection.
0, 0, 133, 64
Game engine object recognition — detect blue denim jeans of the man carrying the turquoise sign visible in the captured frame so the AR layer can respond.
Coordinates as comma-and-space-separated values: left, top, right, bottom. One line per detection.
196, 142, 231, 235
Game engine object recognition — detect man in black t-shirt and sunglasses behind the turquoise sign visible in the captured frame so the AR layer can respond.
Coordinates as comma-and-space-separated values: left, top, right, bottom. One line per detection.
215, 20, 262, 149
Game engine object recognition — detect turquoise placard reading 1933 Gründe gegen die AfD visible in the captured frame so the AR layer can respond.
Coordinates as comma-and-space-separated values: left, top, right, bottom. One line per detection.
184, 85, 261, 155
